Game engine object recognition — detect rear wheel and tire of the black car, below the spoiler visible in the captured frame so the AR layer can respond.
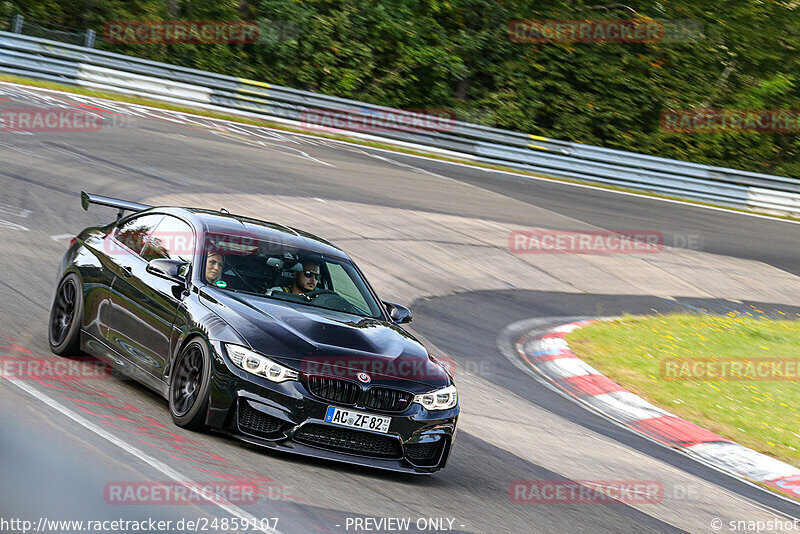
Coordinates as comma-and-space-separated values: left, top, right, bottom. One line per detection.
47, 273, 83, 356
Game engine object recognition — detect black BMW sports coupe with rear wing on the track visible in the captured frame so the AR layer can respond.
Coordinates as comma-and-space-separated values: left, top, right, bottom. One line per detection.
49, 192, 459, 474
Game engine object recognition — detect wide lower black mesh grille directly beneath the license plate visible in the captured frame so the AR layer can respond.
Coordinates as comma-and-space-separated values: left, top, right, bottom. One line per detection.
294, 424, 400, 458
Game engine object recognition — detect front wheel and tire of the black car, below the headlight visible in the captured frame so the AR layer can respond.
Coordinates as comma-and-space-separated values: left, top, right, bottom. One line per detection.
169, 338, 211, 430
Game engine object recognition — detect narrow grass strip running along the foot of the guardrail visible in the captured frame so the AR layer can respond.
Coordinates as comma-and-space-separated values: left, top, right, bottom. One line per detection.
0, 74, 798, 220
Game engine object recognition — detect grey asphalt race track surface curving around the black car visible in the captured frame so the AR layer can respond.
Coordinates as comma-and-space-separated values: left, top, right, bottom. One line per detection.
0, 81, 800, 533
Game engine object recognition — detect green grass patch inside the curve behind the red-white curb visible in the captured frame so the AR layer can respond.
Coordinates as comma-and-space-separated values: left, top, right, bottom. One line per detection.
567, 314, 800, 467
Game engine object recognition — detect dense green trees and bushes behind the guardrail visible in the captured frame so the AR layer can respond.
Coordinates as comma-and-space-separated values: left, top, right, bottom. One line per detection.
0, 0, 800, 177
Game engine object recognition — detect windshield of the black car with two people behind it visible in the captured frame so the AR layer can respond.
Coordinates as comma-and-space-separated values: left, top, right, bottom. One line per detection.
202, 234, 382, 319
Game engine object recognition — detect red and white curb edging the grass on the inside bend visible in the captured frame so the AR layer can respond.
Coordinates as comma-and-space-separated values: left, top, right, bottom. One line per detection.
515, 320, 800, 500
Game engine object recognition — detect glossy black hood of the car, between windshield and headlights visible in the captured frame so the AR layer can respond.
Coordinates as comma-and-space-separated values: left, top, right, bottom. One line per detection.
200, 288, 450, 389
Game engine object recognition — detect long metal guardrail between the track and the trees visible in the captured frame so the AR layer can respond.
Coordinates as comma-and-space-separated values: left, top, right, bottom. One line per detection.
0, 32, 800, 215
